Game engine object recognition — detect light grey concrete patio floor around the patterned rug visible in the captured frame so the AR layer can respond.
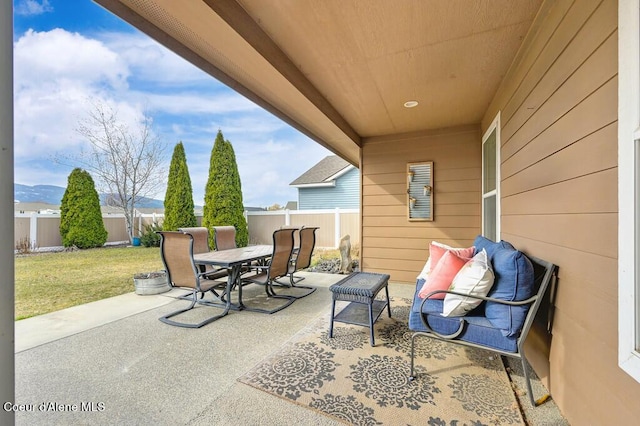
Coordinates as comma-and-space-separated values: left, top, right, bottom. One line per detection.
15, 272, 567, 426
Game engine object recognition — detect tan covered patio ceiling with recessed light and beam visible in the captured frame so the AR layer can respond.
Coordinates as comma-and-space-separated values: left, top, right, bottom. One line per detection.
95, 0, 543, 165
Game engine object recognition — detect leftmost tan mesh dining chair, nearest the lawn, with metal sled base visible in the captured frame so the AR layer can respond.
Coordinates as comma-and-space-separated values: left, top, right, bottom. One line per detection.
158, 231, 226, 328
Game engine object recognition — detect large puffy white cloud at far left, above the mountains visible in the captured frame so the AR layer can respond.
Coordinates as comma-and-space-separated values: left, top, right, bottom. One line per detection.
14, 29, 137, 161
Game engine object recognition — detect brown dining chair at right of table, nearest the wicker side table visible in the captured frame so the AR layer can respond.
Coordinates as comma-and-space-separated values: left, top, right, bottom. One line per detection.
242, 229, 298, 314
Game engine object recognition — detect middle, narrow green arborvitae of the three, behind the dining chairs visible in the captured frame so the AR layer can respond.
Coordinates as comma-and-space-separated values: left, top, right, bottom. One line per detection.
162, 142, 198, 231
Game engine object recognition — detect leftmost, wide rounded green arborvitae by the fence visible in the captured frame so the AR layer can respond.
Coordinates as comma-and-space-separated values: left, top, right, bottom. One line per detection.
60, 168, 107, 249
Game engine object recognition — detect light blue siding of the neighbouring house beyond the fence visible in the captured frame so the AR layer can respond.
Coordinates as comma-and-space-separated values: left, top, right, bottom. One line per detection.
298, 168, 360, 210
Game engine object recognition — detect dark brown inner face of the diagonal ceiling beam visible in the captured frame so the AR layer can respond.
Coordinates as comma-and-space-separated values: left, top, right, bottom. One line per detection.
204, 0, 362, 147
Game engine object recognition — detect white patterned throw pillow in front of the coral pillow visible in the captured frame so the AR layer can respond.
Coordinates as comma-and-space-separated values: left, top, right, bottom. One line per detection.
442, 249, 494, 317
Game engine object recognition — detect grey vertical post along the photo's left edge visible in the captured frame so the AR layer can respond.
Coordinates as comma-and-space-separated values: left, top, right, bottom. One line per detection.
0, 1, 16, 425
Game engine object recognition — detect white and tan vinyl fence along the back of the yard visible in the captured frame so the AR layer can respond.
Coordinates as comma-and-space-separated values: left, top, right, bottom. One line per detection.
14, 209, 360, 250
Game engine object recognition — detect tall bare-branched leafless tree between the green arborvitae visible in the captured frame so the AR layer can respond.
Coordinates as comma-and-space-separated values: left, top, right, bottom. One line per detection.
73, 101, 167, 239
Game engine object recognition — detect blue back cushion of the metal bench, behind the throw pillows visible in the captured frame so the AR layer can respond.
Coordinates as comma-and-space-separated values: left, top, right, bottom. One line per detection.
473, 236, 535, 337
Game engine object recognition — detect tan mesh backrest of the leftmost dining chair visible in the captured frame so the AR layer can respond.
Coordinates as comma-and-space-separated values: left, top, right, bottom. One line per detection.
158, 231, 198, 288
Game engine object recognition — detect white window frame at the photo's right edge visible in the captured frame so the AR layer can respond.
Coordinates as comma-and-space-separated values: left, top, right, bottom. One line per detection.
618, 0, 640, 382
